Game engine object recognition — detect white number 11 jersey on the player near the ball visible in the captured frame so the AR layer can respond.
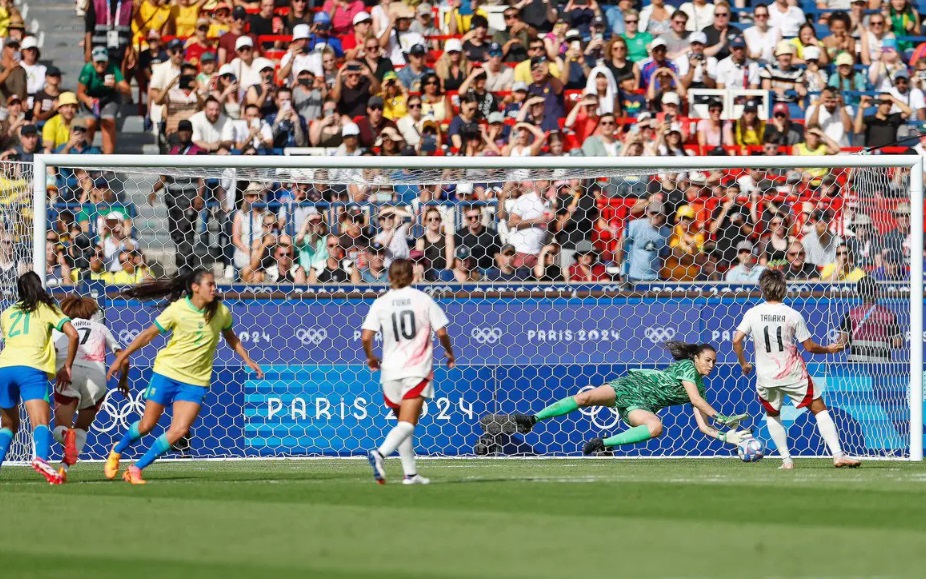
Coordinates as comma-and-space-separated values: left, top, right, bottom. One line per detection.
736, 303, 810, 388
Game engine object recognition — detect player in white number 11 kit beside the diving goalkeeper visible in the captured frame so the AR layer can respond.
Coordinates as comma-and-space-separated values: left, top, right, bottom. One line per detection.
733, 269, 861, 469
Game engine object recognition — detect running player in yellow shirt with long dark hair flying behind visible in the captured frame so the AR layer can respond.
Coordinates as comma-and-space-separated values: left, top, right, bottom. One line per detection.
103, 269, 264, 484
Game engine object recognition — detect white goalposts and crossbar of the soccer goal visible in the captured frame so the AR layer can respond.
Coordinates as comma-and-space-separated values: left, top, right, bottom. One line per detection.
33, 154, 924, 461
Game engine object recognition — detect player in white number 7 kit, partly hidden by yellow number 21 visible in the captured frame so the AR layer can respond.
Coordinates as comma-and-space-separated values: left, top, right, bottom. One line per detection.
52, 296, 129, 478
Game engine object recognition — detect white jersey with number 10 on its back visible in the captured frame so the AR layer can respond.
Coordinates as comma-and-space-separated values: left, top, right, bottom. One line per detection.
362, 287, 449, 382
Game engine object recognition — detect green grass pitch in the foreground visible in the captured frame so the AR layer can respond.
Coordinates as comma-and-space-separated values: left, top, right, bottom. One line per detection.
0, 459, 926, 579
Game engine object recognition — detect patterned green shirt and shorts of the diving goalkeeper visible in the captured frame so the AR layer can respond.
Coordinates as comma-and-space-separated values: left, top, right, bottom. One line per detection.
611, 360, 704, 412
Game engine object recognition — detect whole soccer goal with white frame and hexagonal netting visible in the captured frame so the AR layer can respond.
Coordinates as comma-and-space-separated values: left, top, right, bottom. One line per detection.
4, 155, 923, 459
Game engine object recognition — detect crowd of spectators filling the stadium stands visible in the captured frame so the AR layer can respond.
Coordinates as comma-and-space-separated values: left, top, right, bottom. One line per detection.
9, 0, 926, 283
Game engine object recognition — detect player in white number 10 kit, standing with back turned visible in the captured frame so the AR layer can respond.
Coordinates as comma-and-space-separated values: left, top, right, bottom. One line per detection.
360, 259, 455, 485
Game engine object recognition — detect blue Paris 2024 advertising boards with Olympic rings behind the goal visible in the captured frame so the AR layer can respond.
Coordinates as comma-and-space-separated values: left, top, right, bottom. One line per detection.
81, 296, 909, 457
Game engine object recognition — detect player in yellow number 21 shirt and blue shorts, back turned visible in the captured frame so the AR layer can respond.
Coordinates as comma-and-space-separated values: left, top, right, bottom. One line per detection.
0, 271, 78, 485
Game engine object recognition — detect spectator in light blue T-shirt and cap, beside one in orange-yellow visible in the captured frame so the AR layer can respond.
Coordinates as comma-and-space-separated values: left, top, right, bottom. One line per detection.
614, 201, 672, 283
